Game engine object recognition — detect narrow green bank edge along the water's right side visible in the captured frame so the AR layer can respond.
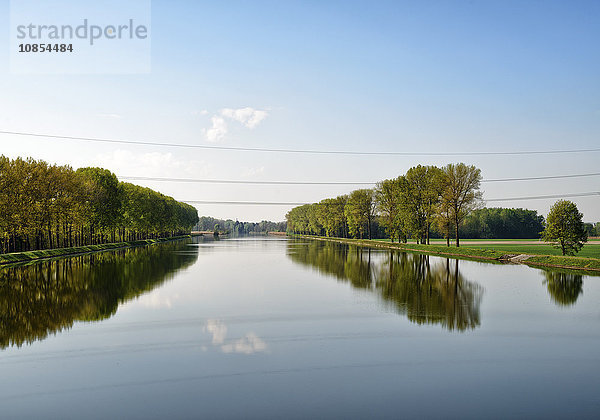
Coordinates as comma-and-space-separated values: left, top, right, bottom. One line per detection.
296, 235, 600, 275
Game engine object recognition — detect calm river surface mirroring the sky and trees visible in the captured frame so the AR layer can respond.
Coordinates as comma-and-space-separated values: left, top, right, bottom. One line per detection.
0, 238, 600, 419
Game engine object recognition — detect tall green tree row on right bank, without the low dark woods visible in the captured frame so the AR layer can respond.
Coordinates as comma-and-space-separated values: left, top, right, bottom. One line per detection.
286, 163, 481, 246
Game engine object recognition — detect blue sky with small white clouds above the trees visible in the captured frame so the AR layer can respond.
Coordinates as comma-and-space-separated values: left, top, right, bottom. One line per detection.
0, 0, 600, 221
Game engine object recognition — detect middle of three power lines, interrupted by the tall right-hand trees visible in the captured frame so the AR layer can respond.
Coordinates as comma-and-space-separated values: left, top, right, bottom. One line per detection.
118, 172, 600, 185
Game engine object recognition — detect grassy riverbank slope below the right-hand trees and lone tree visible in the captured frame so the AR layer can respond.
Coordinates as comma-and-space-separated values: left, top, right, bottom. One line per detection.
301, 236, 600, 272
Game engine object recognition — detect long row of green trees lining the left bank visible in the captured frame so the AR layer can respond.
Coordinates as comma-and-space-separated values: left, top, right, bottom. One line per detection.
0, 156, 198, 253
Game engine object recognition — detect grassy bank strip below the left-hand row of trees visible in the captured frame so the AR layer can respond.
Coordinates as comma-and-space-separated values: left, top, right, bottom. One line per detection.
0, 234, 202, 266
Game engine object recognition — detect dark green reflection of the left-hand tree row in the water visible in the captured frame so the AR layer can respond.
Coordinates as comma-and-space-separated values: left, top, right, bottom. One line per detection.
0, 242, 198, 348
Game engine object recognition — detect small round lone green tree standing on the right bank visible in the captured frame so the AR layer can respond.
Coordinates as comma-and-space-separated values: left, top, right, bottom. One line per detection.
542, 200, 588, 255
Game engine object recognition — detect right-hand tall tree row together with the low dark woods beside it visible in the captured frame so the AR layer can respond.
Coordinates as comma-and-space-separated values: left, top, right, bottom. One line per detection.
286, 163, 564, 245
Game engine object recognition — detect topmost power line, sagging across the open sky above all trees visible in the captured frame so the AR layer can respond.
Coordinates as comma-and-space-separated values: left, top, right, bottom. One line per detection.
0, 130, 600, 156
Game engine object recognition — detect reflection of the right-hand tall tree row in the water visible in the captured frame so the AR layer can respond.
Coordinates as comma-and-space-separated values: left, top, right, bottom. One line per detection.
288, 241, 483, 331
